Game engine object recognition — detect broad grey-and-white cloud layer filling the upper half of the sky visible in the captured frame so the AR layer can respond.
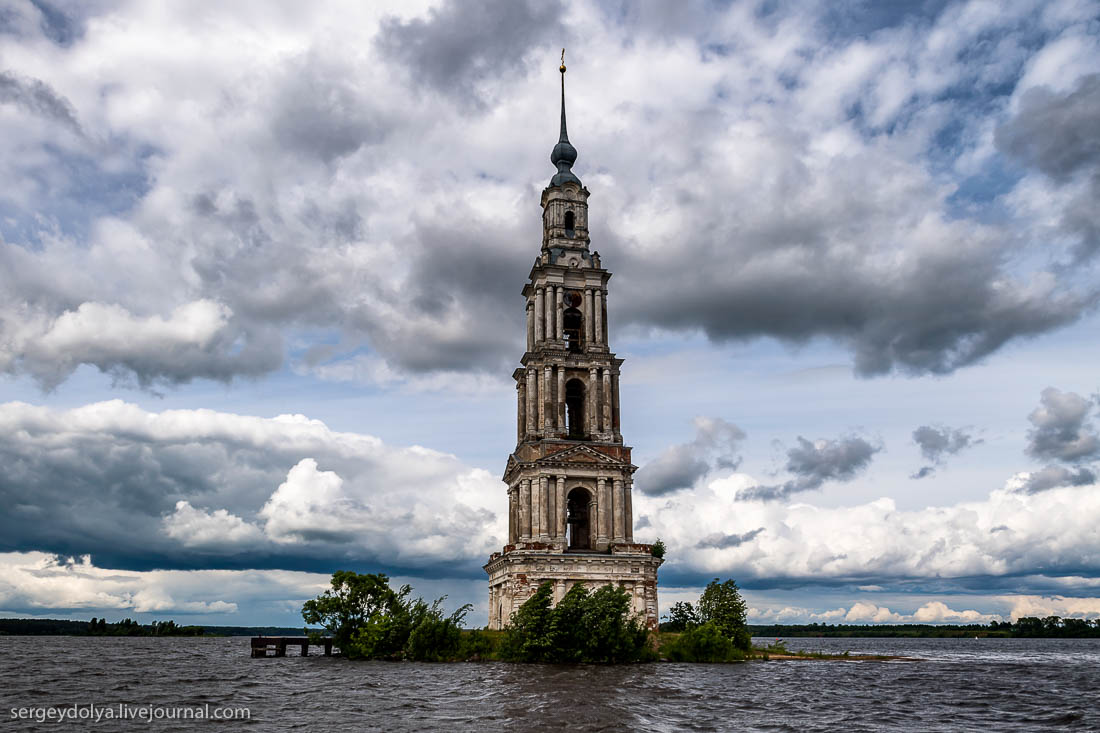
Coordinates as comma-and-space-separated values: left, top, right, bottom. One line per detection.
0, 1, 1100, 389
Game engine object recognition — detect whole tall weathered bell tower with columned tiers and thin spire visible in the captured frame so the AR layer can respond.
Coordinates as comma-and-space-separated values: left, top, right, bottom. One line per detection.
484, 57, 661, 628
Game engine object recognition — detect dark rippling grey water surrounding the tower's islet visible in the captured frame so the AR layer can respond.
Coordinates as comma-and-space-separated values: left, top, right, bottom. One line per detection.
0, 636, 1100, 731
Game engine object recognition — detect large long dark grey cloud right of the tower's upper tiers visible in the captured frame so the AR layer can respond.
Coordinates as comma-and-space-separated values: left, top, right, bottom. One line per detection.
623, 235, 1097, 376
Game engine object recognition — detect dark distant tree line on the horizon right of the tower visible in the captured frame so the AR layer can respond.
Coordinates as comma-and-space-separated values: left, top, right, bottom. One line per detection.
739, 606, 1100, 638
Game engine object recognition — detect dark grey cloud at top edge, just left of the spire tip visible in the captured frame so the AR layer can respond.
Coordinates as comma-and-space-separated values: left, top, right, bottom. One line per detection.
377, 0, 567, 106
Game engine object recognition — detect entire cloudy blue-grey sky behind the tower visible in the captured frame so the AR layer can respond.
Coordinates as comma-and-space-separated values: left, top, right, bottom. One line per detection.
0, 0, 1100, 625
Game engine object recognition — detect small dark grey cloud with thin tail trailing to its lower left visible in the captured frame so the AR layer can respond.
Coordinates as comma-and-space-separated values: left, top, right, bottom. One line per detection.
737, 436, 882, 501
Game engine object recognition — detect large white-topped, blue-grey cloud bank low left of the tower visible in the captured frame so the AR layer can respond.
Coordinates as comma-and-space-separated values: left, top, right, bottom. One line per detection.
0, 401, 506, 577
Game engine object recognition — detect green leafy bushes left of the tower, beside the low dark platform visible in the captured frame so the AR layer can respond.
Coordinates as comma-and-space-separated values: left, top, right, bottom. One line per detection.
301, 570, 471, 661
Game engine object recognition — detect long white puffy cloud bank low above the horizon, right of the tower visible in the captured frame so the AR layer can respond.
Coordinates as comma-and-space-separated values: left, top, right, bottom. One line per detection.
635, 475, 1100, 592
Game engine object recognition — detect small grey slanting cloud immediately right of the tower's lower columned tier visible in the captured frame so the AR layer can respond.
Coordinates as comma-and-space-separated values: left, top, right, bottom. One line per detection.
636, 417, 745, 496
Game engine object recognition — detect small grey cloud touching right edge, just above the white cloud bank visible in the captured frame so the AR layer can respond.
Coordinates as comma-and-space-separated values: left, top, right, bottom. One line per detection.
1027, 387, 1100, 462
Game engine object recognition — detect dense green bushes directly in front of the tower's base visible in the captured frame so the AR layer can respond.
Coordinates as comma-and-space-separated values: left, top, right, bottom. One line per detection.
501, 582, 657, 664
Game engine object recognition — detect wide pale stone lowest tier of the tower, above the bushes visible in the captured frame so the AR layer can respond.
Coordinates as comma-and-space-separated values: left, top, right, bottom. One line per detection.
484, 543, 663, 631
